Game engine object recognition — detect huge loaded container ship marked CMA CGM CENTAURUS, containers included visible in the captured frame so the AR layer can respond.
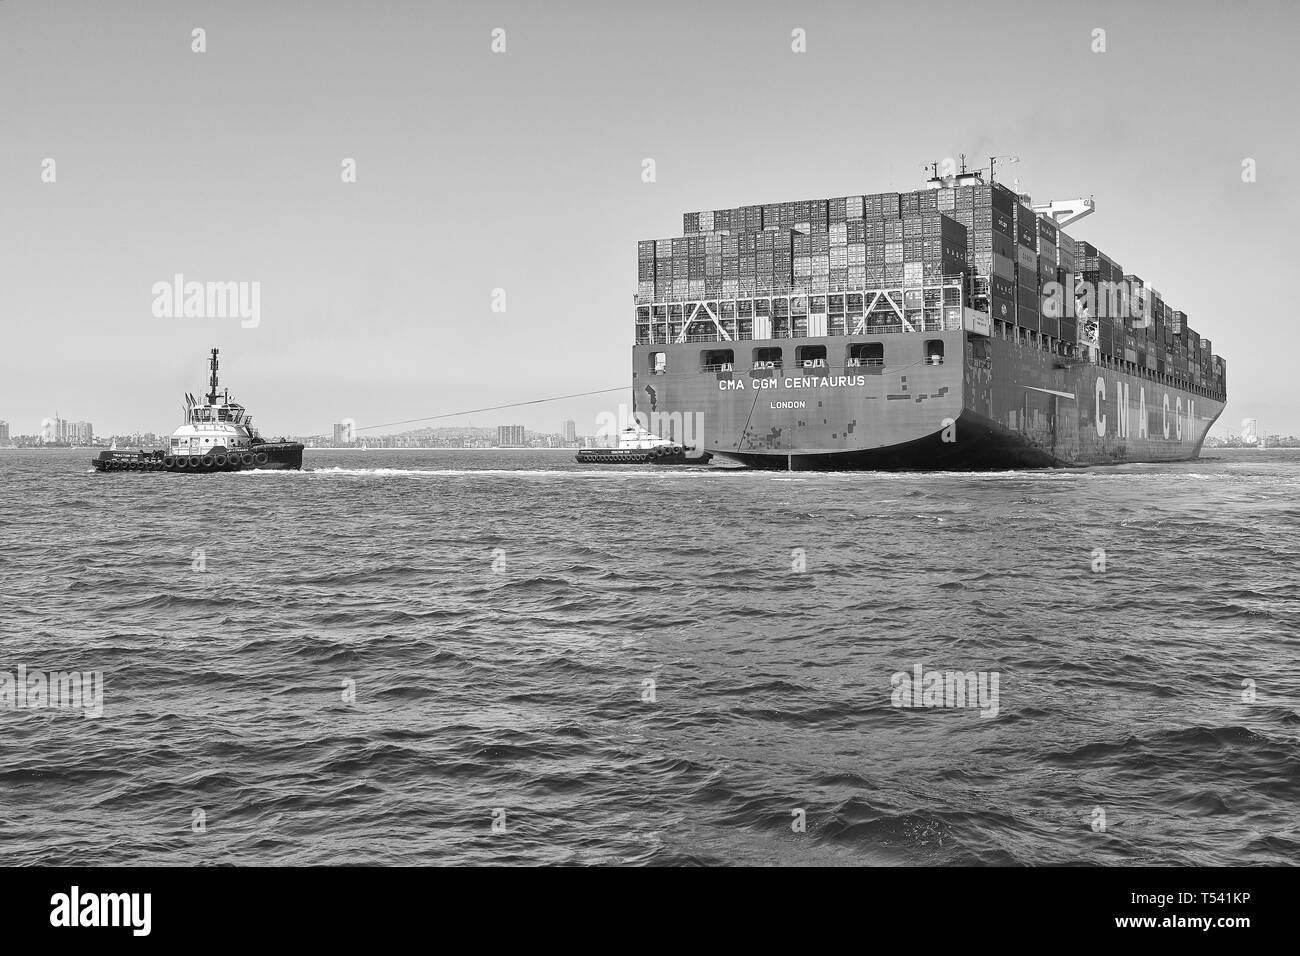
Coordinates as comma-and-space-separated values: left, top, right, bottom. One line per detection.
632, 163, 1227, 470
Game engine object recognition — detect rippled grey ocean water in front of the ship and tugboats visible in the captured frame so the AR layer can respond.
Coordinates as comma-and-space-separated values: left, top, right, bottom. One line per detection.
0, 450, 1300, 865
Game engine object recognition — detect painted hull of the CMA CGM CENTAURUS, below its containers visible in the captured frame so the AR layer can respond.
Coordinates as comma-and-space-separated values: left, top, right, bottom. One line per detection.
633, 330, 1223, 471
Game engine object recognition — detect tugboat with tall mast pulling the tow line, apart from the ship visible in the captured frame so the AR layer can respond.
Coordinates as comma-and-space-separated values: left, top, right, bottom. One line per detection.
91, 349, 303, 475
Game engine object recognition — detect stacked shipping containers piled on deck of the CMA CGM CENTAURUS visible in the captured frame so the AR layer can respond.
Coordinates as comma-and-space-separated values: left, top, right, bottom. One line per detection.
637, 183, 1226, 390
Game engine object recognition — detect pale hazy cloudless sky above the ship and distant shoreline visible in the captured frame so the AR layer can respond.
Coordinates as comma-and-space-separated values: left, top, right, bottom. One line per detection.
0, 0, 1300, 433
